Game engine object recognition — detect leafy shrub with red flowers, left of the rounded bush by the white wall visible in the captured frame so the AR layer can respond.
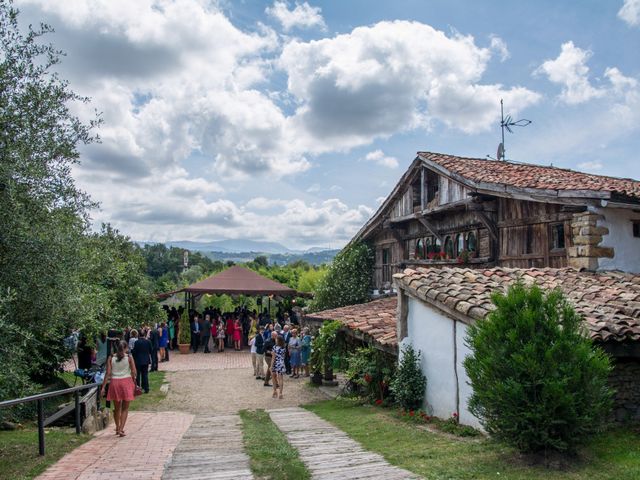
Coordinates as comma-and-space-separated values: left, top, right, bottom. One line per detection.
347, 347, 395, 405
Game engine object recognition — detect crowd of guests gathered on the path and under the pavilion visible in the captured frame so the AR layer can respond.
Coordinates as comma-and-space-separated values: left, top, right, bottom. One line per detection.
78, 307, 312, 437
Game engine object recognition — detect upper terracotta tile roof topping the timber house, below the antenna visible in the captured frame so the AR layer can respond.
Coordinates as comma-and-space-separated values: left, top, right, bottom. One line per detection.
418, 152, 640, 200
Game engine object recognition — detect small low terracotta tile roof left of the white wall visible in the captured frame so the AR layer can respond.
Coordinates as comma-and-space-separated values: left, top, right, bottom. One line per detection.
306, 296, 398, 348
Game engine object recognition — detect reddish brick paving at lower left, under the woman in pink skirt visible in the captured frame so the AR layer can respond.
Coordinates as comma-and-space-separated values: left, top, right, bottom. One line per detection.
38, 412, 193, 480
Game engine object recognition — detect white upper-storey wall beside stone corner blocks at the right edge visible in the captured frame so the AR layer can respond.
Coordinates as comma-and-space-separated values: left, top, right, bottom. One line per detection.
593, 208, 640, 273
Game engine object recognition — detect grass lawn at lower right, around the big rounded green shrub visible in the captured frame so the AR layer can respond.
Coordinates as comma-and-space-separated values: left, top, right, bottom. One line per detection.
305, 400, 640, 480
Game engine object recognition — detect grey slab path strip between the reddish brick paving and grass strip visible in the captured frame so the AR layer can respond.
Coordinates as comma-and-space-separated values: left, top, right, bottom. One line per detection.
162, 415, 253, 480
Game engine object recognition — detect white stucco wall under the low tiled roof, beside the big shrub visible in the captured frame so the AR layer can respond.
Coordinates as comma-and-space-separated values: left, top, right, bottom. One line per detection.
400, 297, 481, 428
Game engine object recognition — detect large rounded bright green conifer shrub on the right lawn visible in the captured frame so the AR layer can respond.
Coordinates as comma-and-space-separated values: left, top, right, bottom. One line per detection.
464, 283, 612, 452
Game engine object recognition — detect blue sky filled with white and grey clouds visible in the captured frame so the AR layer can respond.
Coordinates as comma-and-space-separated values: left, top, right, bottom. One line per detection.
16, 0, 640, 248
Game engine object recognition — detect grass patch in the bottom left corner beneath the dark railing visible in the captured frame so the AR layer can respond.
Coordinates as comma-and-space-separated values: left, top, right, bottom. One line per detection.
0, 427, 91, 480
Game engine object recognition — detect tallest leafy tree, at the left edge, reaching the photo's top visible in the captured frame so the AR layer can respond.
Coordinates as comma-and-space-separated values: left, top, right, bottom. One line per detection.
0, 0, 100, 379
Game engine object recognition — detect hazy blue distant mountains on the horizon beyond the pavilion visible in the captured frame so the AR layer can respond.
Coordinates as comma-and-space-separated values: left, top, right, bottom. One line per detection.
137, 240, 340, 265
